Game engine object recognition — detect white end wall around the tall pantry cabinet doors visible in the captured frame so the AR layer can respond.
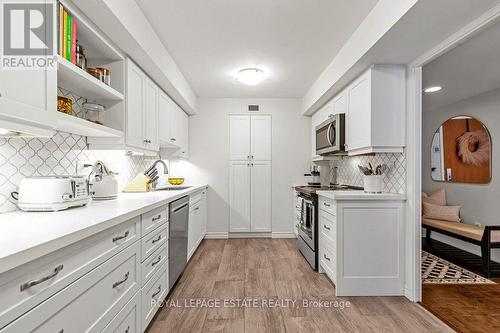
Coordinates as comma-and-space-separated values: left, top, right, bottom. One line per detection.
172, 98, 311, 233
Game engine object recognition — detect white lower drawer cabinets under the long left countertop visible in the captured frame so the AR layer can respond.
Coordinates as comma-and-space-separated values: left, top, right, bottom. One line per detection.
0, 202, 174, 333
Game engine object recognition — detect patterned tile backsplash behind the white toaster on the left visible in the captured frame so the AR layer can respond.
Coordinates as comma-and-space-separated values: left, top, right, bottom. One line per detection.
0, 132, 161, 213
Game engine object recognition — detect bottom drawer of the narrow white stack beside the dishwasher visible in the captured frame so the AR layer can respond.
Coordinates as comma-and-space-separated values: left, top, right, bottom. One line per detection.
142, 265, 168, 331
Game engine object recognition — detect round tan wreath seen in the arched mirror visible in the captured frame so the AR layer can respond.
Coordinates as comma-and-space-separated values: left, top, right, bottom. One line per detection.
457, 130, 490, 166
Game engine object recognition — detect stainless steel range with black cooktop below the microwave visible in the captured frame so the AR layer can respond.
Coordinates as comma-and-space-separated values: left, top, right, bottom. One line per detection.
295, 185, 359, 271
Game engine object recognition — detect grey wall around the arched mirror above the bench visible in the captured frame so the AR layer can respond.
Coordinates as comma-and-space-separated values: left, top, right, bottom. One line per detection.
422, 89, 500, 261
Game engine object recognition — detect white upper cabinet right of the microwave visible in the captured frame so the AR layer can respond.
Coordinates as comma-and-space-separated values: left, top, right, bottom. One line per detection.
346, 66, 406, 155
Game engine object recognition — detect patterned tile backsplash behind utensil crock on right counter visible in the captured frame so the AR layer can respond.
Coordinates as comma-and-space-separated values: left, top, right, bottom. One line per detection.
330, 153, 406, 193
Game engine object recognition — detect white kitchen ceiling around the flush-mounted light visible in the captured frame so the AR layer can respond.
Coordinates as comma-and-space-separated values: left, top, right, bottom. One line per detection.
136, 0, 377, 98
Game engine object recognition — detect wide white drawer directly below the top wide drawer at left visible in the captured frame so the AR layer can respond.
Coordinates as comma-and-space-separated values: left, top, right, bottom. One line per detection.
2, 243, 140, 333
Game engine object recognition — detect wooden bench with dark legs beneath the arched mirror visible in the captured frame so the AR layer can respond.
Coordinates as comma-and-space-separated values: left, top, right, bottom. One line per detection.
422, 218, 500, 278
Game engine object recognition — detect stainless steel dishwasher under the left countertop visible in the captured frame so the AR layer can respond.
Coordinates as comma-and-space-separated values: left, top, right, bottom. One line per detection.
168, 196, 189, 288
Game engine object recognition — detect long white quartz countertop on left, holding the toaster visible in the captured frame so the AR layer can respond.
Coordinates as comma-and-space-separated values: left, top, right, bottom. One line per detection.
0, 185, 207, 274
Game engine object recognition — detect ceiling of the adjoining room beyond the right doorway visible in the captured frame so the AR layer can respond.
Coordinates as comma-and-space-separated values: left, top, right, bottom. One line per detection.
422, 23, 500, 111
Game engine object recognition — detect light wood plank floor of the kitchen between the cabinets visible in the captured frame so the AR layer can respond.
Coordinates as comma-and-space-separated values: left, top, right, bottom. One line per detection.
148, 239, 452, 333
